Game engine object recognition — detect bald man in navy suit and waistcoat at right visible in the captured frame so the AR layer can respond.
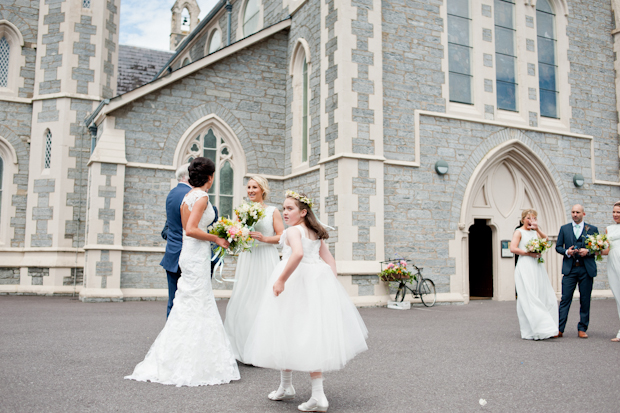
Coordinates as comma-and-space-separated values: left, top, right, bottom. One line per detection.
555, 205, 598, 338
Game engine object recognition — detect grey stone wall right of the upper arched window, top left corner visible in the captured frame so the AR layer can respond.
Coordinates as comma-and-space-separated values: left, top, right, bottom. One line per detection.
0, 1, 40, 98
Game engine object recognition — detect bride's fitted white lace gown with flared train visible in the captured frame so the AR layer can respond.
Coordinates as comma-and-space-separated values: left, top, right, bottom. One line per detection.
125, 190, 239, 387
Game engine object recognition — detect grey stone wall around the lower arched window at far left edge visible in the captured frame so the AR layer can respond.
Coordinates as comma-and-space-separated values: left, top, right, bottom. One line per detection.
0, 106, 32, 247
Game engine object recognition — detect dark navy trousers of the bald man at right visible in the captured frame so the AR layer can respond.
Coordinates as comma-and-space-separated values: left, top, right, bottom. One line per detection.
559, 265, 594, 331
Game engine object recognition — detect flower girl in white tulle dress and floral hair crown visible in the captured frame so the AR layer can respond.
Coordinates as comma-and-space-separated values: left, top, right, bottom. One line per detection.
244, 191, 368, 412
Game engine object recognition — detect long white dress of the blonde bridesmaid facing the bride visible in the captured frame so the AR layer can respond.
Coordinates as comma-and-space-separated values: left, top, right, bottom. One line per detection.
224, 206, 280, 362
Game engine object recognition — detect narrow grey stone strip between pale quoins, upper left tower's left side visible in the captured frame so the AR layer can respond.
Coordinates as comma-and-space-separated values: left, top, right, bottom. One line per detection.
39, 0, 65, 95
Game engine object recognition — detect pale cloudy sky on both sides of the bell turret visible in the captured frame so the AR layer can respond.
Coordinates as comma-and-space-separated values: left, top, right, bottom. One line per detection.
119, 0, 217, 50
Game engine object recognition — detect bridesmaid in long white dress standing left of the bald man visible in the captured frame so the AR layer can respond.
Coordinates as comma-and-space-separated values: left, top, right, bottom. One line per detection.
510, 209, 559, 340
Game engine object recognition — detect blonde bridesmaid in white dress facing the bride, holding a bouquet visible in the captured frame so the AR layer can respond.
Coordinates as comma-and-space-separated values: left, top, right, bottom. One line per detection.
224, 175, 284, 363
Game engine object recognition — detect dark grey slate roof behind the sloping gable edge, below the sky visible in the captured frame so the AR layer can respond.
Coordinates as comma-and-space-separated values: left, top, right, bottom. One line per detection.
116, 45, 174, 95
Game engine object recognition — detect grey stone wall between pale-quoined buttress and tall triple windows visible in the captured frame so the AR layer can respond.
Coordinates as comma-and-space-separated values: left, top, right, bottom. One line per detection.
381, 0, 446, 161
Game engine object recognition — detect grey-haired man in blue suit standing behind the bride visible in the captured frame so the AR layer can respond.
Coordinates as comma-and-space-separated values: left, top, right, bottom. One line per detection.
159, 164, 192, 317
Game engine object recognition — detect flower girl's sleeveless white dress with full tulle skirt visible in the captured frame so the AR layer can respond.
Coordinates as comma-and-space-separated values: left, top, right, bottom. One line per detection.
243, 226, 368, 372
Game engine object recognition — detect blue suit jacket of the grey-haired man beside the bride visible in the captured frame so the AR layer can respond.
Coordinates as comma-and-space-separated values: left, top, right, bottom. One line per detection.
159, 183, 192, 272
